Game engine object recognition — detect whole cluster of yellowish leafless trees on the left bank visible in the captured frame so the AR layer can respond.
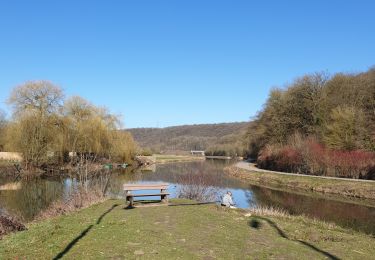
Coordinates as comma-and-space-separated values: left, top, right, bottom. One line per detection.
0, 81, 136, 169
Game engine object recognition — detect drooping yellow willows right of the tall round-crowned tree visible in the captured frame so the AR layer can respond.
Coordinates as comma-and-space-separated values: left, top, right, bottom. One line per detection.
63, 97, 135, 164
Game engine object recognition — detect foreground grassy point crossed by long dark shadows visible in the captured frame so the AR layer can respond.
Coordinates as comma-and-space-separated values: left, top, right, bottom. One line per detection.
0, 200, 375, 259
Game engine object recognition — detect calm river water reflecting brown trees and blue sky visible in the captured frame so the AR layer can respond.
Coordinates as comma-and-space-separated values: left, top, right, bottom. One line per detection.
0, 160, 375, 233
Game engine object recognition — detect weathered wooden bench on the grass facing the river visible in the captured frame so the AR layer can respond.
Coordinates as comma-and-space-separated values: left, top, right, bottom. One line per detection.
124, 183, 169, 207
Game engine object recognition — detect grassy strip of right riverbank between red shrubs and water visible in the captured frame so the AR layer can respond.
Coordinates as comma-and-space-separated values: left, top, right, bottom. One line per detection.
225, 162, 375, 200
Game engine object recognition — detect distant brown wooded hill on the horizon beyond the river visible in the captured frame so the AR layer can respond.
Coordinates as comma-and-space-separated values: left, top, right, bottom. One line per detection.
127, 122, 249, 152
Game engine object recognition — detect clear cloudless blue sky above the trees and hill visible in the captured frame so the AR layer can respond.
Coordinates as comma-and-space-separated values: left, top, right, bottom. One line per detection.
0, 0, 375, 127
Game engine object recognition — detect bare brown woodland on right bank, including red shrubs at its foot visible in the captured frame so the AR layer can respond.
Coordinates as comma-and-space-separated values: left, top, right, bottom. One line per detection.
246, 68, 375, 178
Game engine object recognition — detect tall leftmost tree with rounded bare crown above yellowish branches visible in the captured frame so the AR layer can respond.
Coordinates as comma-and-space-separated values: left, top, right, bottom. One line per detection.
7, 81, 63, 168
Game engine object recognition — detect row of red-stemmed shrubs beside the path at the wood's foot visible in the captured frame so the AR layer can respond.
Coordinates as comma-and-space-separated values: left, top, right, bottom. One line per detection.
257, 138, 375, 179
